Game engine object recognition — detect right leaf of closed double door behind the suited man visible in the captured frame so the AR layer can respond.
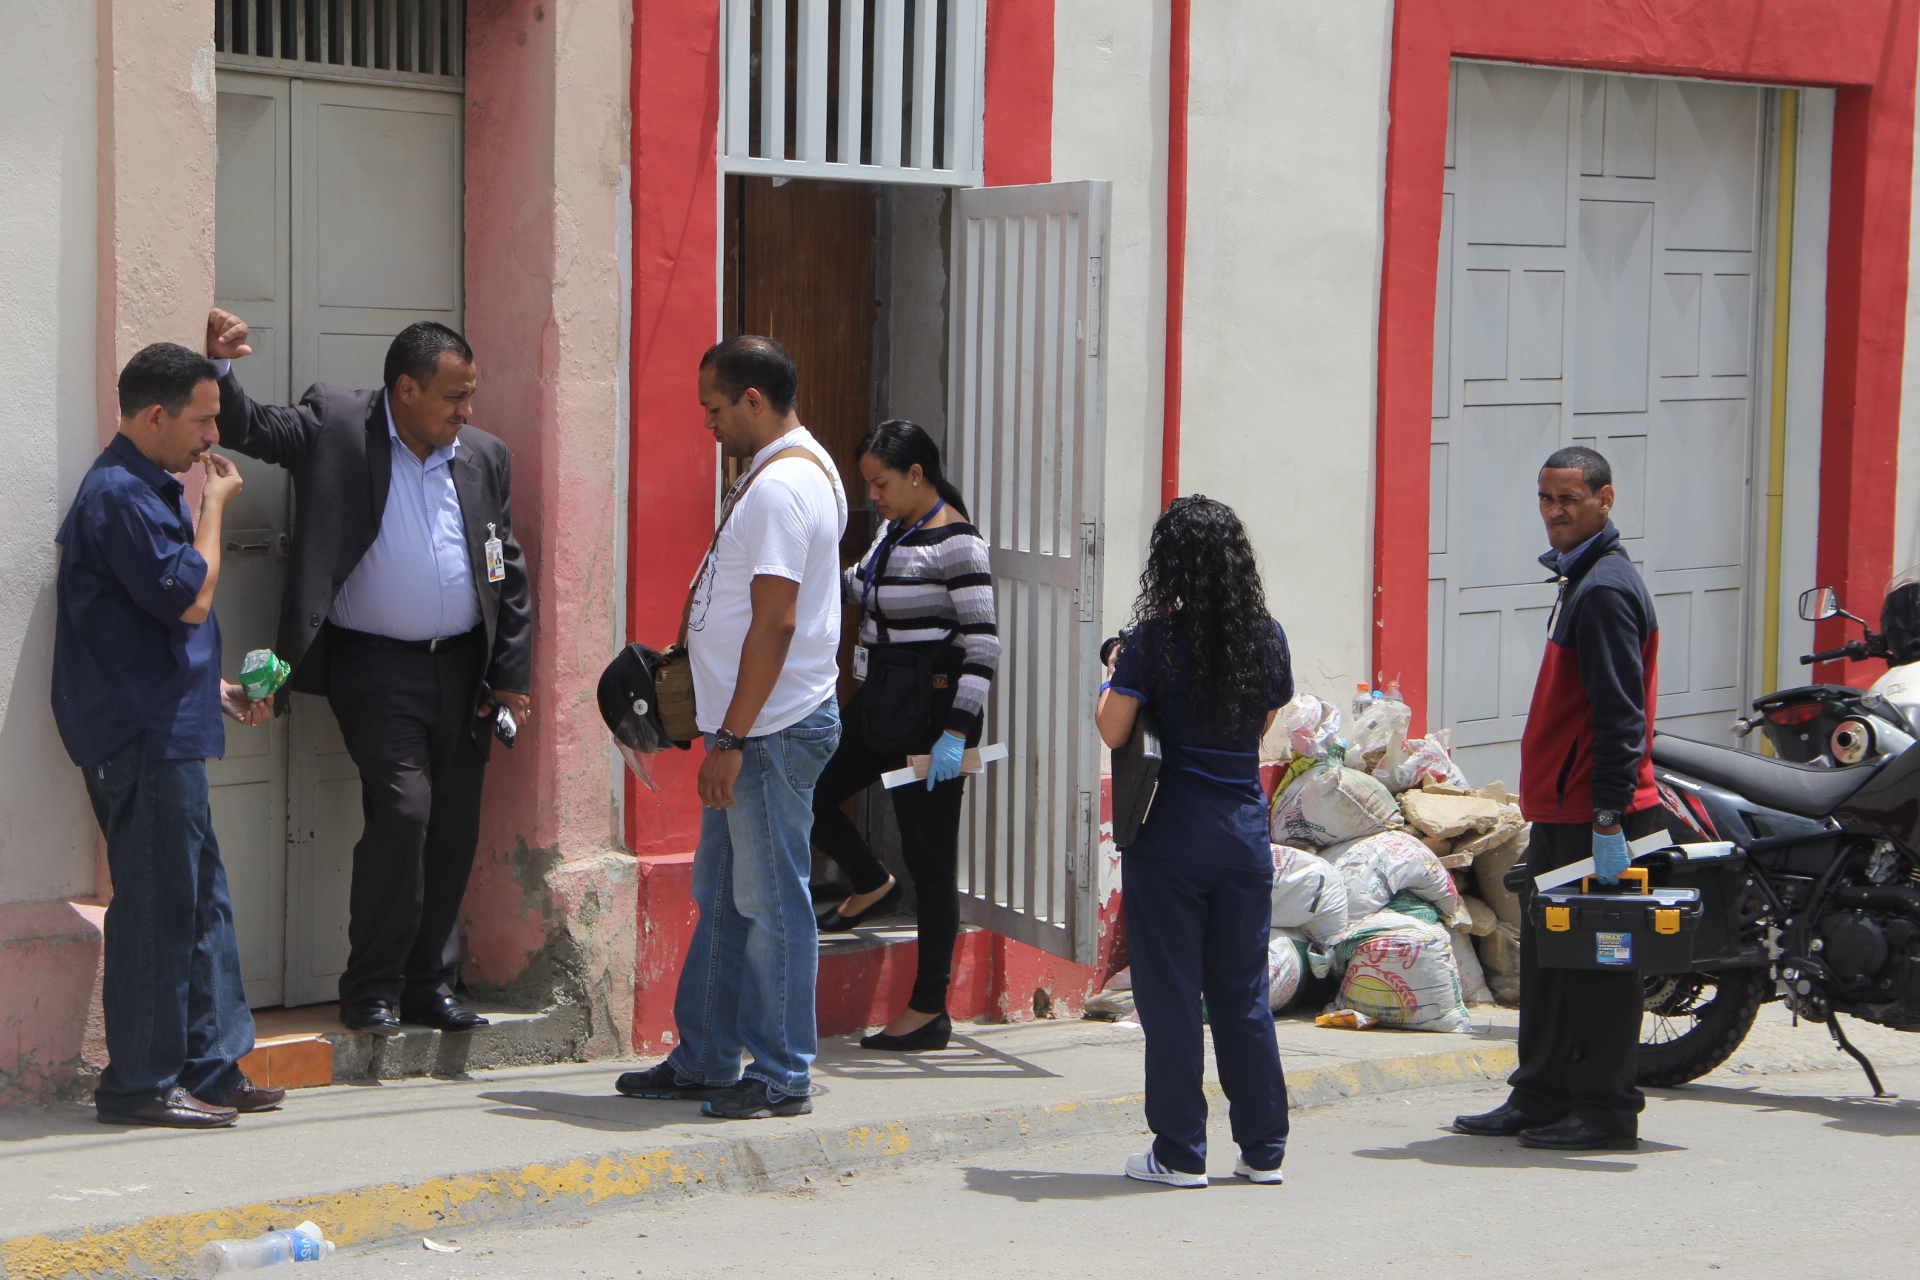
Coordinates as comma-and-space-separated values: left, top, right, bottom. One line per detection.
286, 81, 464, 1004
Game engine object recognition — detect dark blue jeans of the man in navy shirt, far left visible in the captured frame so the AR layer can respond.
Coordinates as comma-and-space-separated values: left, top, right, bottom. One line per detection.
81, 739, 253, 1111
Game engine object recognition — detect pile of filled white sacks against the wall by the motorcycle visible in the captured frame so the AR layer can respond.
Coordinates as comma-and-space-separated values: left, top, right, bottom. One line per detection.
1267, 695, 1528, 1031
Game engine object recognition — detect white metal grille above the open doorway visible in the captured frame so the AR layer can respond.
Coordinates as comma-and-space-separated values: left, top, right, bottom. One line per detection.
720, 0, 987, 186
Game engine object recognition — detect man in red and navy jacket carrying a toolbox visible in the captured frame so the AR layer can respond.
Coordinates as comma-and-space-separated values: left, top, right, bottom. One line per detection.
1453, 445, 1663, 1151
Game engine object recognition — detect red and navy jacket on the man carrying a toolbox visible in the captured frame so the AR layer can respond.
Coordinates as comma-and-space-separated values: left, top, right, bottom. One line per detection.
1521, 522, 1661, 825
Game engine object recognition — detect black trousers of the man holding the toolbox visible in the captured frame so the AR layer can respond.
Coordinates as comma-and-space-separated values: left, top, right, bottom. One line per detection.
1507, 806, 1665, 1136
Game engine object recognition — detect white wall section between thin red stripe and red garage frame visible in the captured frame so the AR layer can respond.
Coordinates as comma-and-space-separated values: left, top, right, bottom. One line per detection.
1181, 0, 1394, 704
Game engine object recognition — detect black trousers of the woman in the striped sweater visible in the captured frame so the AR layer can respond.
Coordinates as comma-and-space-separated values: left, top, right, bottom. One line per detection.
812, 691, 966, 1013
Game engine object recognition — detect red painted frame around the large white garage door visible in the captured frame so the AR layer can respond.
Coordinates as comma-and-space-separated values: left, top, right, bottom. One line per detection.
1373, 0, 1916, 714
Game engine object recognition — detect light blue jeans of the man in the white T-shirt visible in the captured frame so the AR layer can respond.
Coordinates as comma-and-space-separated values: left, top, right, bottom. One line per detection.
666, 699, 839, 1100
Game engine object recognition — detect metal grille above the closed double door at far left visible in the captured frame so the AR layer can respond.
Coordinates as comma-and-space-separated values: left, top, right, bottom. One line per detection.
213, 0, 467, 88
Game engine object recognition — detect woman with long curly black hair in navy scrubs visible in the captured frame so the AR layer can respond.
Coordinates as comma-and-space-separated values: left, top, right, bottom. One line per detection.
1096, 495, 1294, 1186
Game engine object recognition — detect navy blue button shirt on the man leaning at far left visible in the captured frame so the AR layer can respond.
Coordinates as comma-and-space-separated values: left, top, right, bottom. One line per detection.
54, 436, 227, 770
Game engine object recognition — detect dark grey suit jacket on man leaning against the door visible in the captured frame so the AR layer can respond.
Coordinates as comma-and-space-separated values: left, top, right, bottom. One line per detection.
219, 370, 534, 736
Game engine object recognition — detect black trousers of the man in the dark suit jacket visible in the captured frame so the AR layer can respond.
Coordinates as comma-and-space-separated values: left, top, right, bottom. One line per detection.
326, 631, 486, 1004
